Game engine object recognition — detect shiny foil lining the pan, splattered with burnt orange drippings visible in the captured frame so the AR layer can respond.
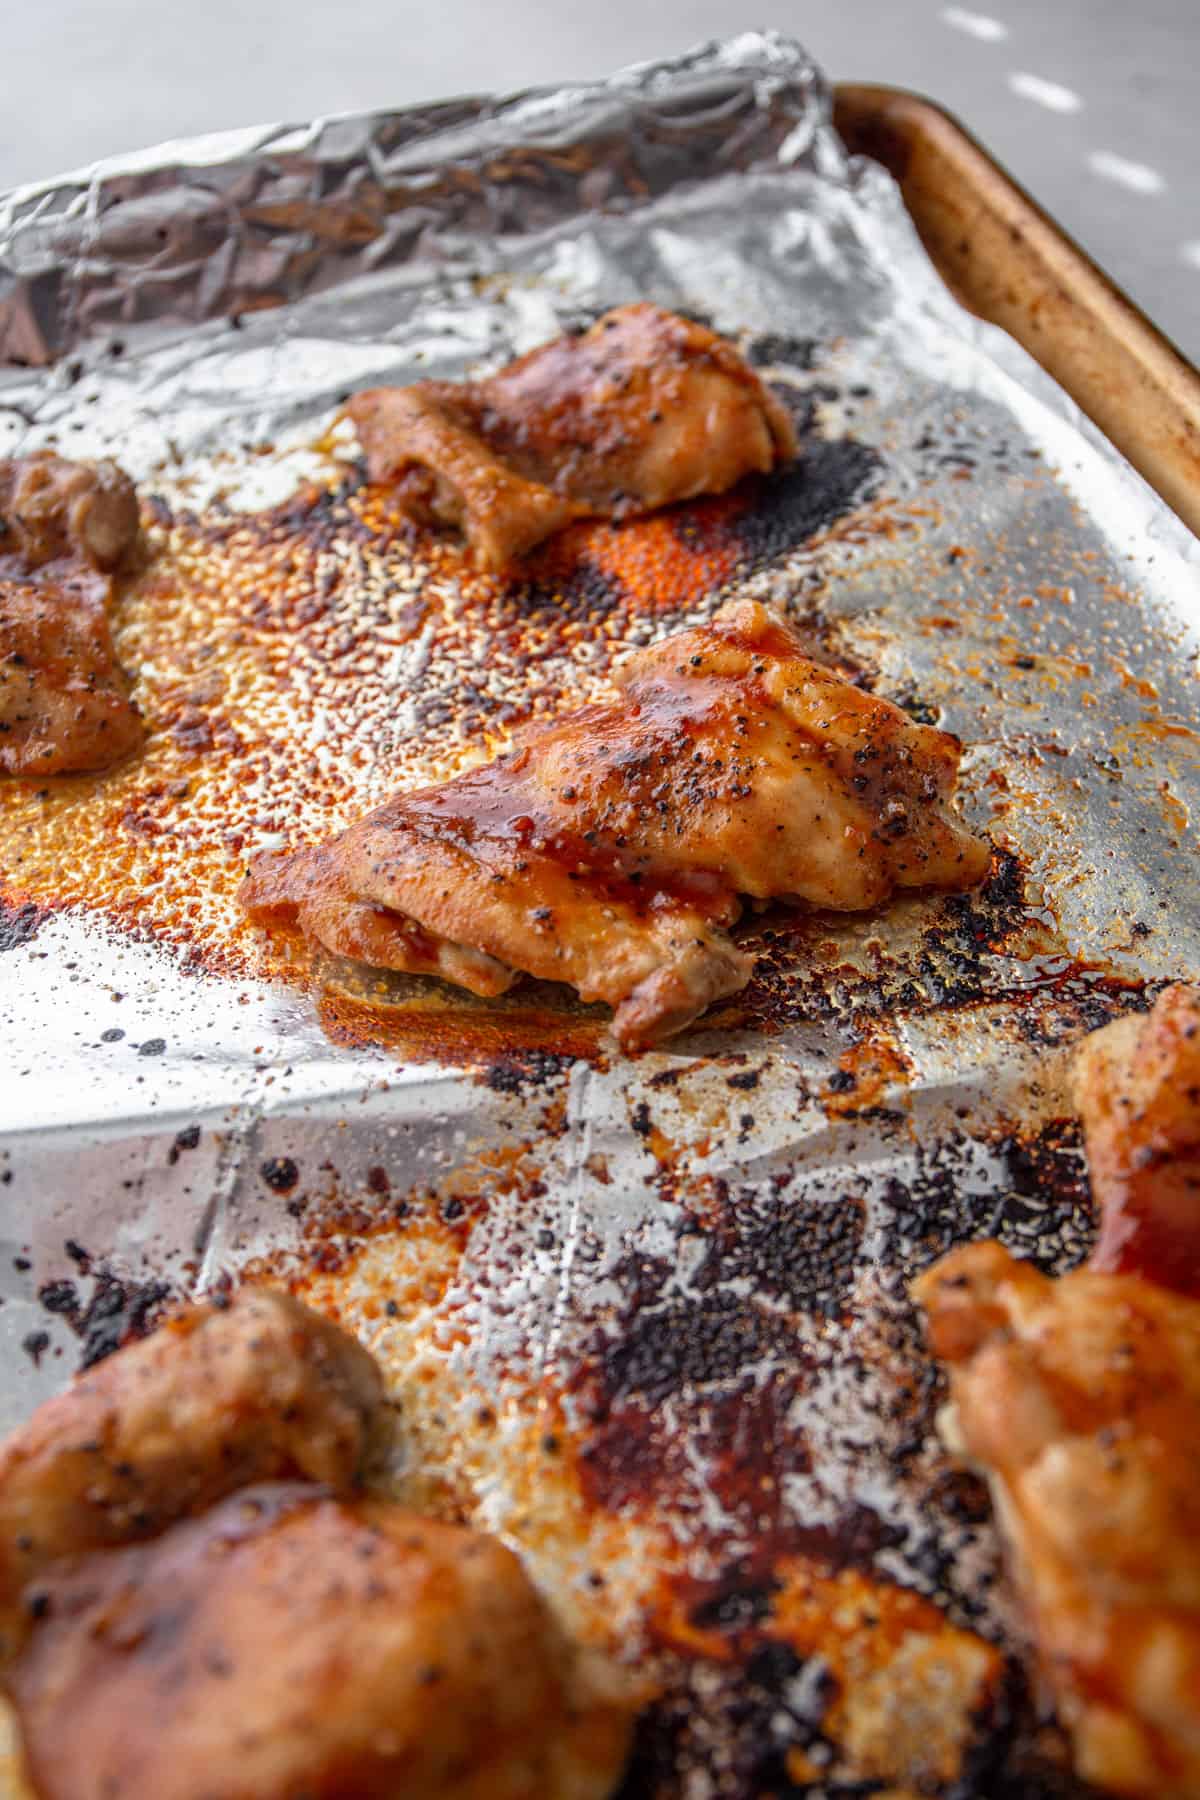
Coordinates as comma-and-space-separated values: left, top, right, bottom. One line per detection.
0, 34, 1200, 1800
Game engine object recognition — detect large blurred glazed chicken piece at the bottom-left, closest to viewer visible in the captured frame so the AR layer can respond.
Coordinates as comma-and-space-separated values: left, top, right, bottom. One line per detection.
9, 1487, 628, 1800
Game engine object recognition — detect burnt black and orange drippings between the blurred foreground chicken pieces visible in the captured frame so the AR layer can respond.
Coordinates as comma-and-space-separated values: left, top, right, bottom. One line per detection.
248, 1087, 1090, 1800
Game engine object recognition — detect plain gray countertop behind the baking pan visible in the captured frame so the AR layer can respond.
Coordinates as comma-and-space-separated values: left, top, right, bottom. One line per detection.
0, 0, 1200, 360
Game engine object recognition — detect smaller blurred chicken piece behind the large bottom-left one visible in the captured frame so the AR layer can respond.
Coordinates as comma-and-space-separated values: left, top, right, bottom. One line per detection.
0, 1291, 383, 1658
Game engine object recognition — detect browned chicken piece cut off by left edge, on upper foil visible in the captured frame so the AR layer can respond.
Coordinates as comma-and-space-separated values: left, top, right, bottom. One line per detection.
0, 450, 144, 776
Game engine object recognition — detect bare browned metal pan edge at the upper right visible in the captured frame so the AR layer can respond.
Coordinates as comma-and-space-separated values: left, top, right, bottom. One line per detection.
833, 81, 1200, 536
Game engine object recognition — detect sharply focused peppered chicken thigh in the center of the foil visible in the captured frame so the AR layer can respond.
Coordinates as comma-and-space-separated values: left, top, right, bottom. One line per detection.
241, 601, 990, 1049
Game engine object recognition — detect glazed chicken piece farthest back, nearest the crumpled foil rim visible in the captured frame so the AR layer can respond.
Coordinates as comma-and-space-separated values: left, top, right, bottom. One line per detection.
347, 302, 797, 571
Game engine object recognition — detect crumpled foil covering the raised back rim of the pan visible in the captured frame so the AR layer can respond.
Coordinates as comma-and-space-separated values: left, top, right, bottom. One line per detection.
0, 31, 847, 367
